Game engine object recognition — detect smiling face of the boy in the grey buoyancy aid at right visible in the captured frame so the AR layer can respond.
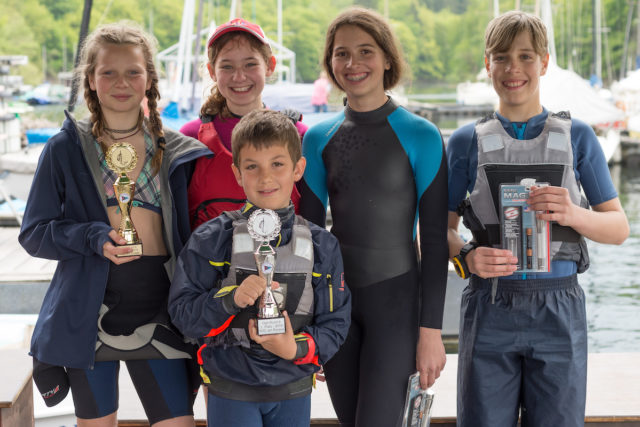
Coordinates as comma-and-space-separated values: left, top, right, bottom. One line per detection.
485, 31, 549, 121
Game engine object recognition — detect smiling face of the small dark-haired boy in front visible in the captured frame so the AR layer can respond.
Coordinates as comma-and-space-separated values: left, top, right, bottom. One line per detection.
231, 144, 306, 210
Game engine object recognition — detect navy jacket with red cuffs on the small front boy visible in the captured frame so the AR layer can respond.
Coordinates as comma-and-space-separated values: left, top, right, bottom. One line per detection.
169, 207, 351, 386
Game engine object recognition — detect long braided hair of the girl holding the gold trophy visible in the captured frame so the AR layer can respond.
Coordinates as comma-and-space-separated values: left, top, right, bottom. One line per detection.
76, 22, 165, 174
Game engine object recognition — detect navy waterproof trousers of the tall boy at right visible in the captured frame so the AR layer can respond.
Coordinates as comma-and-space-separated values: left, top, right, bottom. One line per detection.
457, 275, 587, 427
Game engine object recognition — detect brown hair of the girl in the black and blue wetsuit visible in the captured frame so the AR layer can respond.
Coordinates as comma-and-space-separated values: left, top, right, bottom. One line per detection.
322, 7, 405, 90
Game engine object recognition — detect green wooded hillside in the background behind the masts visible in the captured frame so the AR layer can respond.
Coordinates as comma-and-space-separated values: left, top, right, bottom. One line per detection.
0, 0, 640, 89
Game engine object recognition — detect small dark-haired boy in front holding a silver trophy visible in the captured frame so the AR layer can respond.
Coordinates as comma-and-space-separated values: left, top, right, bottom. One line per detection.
169, 110, 351, 427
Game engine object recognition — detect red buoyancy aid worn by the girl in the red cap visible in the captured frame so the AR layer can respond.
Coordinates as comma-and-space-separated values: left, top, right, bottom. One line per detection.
188, 116, 300, 230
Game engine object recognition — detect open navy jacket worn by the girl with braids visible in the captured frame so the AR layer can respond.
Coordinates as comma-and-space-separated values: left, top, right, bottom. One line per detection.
19, 114, 210, 368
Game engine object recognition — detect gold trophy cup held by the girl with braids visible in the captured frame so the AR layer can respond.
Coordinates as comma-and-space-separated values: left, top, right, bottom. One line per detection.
105, 142, 142, 257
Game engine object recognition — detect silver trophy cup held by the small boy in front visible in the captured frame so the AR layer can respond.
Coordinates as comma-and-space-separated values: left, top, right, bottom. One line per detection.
247, 209, 285, 335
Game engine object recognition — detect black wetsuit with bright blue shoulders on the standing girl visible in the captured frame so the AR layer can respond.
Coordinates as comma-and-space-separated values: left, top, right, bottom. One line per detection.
300, 100, 448, 427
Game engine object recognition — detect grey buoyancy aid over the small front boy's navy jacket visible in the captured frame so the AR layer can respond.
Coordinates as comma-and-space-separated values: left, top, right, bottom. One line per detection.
205, 211, 314, 353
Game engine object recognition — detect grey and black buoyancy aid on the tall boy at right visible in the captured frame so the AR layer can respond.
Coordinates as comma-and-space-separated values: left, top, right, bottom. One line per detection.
458, 112, 589, 273
